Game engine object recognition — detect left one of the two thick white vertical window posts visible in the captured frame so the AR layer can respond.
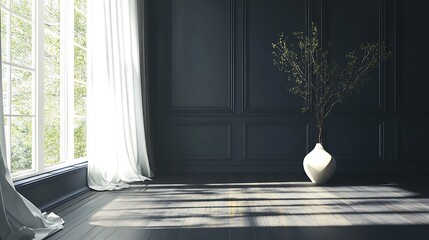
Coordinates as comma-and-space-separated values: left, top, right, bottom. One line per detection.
33, 0, 45, 172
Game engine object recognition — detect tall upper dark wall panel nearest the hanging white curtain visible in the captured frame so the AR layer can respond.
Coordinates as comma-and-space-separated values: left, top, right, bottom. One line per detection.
169, 0, 233, 111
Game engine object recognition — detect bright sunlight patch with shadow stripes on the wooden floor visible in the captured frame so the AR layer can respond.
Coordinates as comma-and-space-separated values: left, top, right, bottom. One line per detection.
89, 182, 429, 229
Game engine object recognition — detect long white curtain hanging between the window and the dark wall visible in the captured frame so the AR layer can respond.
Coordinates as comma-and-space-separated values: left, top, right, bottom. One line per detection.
87, 0, 152, 191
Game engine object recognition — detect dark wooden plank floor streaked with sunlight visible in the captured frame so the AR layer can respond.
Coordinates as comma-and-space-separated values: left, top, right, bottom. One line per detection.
49, 175, 429, 240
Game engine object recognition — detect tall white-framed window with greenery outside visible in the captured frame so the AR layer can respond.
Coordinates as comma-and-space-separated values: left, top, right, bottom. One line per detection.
0, 0, 87, 178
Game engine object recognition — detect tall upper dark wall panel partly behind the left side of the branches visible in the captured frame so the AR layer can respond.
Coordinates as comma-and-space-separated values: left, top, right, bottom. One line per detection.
243, 0, 308, 112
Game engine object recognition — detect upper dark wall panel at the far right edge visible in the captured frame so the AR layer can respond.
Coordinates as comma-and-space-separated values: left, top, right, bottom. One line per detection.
395, 0, 429, 113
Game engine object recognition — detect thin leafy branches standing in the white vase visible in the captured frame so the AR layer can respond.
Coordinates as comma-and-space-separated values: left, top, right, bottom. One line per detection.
272, 23, 390, 143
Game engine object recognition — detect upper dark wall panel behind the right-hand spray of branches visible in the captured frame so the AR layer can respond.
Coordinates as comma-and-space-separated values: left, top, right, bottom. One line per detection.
322, 0, 386, 112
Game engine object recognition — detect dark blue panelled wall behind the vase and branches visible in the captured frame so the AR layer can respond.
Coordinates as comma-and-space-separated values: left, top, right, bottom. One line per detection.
146, 0, 429, 173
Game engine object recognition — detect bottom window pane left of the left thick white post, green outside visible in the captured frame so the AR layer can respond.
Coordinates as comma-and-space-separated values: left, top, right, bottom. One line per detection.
11, 117, 33, 173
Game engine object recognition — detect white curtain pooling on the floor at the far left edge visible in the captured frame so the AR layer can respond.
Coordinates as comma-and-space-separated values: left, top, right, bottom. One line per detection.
0, 40, 64, 240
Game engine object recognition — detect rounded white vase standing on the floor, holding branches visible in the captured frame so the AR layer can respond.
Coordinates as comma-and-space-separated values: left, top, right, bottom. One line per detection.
303, 143, 337, 184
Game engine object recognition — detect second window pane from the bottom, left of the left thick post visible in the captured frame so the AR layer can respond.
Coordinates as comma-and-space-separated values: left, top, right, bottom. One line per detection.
10, 68, 33, 115
